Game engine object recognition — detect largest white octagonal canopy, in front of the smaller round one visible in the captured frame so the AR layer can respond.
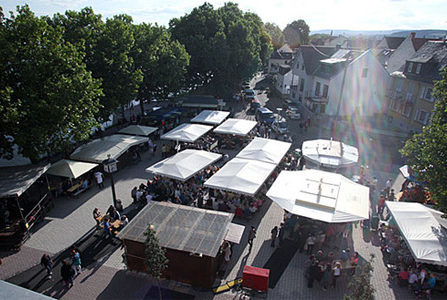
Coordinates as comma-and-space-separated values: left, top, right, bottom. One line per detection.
267, 170, 369, 223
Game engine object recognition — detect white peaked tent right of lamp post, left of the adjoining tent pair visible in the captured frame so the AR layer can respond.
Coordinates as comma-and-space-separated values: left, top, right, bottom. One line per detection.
146, 149, 222, 181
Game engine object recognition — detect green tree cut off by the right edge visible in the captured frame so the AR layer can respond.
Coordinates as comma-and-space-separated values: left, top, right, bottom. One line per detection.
401, 68, 447, 213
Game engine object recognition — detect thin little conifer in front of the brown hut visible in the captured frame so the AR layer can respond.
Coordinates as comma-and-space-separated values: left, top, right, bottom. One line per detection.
144, 225, 169, 299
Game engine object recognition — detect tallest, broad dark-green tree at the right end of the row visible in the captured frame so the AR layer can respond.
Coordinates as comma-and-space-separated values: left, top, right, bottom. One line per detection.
169, 3, 272, 96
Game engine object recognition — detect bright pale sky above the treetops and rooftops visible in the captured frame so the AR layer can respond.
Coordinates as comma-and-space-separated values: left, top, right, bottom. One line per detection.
0, 0, 447, 31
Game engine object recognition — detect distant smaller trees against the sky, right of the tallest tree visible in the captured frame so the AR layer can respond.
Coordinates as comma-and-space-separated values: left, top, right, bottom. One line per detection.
265, 20, 310, 49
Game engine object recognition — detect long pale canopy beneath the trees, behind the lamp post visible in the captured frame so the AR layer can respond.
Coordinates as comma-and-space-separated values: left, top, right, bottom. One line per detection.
70, 134, 148, 163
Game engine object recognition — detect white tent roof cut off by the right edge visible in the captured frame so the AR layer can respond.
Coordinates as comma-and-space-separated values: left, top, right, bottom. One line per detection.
386, 201, 447, 266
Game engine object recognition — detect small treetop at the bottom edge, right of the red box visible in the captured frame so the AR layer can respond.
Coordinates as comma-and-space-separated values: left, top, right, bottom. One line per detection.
344, 254, 375, 300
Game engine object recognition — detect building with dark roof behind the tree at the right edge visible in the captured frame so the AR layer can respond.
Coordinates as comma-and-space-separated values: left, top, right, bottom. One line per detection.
387, 41, 447, 132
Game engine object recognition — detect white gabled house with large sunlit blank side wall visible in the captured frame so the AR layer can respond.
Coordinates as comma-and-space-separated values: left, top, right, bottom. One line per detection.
291, 45, 389, 116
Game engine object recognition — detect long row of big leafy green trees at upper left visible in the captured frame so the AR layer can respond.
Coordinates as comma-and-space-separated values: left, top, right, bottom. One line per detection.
0, 3, 273, 161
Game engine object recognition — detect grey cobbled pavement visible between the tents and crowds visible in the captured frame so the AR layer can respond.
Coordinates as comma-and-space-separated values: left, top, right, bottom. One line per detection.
0, 74, 426, 299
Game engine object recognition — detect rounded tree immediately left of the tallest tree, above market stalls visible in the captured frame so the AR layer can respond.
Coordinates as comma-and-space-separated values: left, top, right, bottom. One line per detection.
132, 23, 190, 115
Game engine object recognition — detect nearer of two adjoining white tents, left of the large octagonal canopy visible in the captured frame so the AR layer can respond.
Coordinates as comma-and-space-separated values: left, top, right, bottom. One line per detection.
204, 158, 276, 196
